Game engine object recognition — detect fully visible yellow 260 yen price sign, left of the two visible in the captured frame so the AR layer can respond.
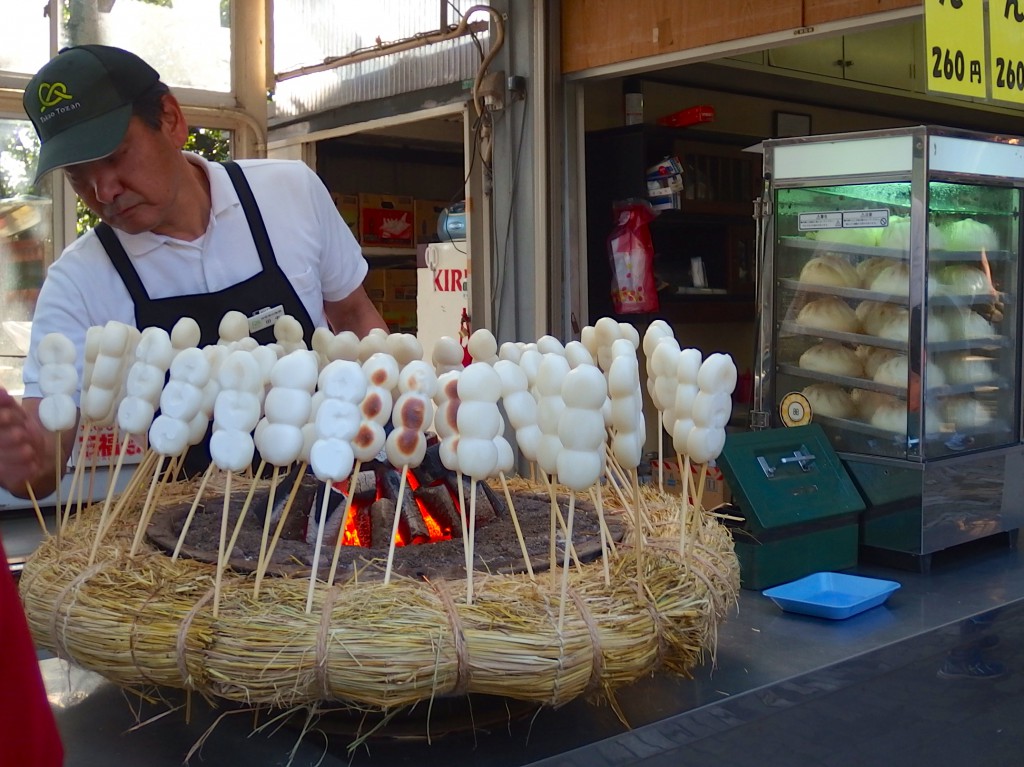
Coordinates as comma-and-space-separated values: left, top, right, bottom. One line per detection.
925, 0, 987, 98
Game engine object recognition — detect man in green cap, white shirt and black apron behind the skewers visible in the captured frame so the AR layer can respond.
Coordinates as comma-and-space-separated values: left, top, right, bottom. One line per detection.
0, 45, 386, 497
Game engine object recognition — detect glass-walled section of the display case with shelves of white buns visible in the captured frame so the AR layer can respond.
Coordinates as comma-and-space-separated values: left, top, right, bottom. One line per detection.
771, 179, 1020, 460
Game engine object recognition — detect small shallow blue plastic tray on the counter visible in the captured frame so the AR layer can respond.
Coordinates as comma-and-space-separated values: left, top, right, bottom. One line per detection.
761, 572, 900, 620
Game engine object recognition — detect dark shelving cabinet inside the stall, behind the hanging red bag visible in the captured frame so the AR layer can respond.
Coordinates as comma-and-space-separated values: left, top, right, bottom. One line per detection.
587, 125, 761, 323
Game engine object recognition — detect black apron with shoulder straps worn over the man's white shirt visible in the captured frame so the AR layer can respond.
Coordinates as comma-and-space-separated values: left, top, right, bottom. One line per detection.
96, 162, 314, 476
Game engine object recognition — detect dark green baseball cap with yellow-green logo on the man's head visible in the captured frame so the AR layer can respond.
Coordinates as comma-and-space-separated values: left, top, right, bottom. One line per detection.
24, 45, 160, 180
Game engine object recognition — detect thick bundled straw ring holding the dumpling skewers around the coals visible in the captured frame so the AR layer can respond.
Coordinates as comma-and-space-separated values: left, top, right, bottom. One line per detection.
20, 481, 739, 710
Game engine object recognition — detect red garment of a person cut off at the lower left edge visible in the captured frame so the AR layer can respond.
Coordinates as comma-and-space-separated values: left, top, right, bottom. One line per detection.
0, 541, 63, 767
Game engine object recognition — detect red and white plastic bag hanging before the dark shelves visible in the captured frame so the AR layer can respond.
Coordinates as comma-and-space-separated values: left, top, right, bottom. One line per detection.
608, 200, 658, 314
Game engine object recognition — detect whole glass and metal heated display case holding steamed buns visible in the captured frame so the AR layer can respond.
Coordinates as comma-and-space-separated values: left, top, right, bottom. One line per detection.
754, 127, 1024, 568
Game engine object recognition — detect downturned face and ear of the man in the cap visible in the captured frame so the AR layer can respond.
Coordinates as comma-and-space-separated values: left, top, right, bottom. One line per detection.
65, 109, 187, 236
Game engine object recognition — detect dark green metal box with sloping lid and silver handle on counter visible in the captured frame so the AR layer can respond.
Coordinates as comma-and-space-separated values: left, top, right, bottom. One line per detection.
719, 424, 864, 589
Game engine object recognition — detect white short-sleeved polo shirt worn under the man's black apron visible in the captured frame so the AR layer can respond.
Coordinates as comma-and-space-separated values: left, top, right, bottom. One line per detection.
24, 153, 368, 397
